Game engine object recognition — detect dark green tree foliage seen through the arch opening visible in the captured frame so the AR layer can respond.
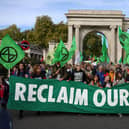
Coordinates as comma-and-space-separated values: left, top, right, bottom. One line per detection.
83, 32, 102, 60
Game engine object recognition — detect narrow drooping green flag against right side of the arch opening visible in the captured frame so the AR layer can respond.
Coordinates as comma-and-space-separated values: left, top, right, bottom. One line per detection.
100, 36, 110, 63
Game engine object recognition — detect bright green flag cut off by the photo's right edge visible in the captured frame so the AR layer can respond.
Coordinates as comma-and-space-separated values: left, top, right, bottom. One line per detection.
119, 26, 129, 64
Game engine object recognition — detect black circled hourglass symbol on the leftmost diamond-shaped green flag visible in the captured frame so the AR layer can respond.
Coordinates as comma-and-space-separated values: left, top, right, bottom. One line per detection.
0, 47, 17, 63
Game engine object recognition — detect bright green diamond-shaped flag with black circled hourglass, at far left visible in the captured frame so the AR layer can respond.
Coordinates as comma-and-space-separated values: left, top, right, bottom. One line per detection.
0, 35, 25, 69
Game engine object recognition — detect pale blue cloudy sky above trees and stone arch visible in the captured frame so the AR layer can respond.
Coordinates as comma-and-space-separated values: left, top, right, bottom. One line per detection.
0, 0, 129, 31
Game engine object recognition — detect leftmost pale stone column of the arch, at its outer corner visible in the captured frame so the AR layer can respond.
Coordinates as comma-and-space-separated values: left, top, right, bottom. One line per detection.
68, 25, 73, 48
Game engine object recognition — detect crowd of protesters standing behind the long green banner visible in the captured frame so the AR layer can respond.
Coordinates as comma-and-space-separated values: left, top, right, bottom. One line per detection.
11, 62, 129, 88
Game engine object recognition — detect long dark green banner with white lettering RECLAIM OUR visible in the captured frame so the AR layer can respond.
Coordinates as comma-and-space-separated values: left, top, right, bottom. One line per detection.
8, 76, 129, 113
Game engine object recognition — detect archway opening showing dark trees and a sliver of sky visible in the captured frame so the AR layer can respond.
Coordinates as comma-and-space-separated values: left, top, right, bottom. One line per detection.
82, 31, 108, 61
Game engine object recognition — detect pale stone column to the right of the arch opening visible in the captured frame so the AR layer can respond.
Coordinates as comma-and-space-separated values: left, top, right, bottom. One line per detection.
109, 26, 116, 63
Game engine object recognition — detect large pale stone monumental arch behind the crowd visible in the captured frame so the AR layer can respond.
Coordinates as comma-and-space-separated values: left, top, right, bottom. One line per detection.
66, 10, 129, 63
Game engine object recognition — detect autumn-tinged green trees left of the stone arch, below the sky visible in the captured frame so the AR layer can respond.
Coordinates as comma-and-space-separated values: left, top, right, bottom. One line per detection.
0, 16, 68, 48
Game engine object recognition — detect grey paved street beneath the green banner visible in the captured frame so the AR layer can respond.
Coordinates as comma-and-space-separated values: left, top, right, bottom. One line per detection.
9, 111, 129, 129
